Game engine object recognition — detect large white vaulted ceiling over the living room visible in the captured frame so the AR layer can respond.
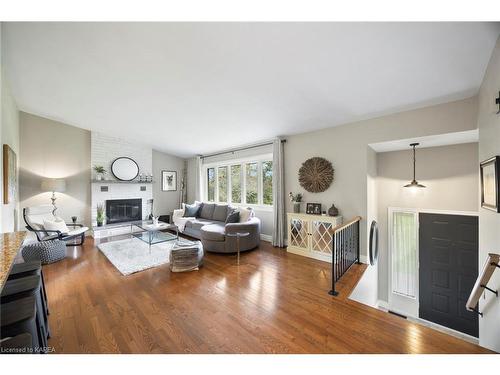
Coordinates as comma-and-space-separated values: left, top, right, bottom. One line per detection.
2, 22, 500, 156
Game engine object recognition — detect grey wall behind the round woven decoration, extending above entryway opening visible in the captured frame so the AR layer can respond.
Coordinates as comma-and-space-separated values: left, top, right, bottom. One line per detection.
285, 97, 477, 255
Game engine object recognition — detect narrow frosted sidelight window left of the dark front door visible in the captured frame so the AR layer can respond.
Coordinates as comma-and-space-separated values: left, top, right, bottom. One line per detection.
391, 211, 417, 298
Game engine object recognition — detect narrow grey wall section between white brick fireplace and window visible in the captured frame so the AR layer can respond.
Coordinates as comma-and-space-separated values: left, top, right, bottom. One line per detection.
153, 150, 184, 219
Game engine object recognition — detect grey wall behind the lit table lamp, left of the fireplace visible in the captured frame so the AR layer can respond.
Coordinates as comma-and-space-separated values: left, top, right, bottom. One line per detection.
19, 112, 91, 226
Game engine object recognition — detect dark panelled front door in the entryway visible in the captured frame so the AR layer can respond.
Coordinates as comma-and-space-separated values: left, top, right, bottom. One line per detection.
419, 213, 478, 337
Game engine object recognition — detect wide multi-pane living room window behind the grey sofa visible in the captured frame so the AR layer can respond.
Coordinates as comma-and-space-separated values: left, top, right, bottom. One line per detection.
205, 155, 273, 207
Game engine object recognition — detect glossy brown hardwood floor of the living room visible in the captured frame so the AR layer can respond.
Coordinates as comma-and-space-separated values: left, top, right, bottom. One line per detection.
44, 239, 488, 353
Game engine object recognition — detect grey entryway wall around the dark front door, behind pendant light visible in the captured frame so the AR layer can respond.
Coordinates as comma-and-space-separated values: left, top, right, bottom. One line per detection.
376, 143, 479, 301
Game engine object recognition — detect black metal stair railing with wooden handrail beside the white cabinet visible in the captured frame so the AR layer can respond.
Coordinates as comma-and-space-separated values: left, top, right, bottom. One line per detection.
328, 216, 361, 296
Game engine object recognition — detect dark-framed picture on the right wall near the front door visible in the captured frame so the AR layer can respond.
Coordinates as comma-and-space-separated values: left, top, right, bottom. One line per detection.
480, 155, 500, 213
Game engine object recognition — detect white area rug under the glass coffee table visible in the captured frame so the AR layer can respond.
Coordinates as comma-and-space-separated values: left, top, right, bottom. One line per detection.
97, 238, 182, 276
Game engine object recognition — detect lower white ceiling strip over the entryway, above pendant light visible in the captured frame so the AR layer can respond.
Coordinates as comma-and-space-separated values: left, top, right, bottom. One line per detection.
369, 129, 479, 152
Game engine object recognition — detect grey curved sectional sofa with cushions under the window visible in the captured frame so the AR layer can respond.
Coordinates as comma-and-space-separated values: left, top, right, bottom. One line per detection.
173, 203, 261, 253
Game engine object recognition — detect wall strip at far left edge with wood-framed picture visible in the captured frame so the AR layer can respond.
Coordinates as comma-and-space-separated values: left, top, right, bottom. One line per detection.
0, 27, 19, 232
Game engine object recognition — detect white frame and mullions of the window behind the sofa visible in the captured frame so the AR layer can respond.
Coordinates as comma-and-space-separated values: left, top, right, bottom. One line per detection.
202, 154, 274, 211
